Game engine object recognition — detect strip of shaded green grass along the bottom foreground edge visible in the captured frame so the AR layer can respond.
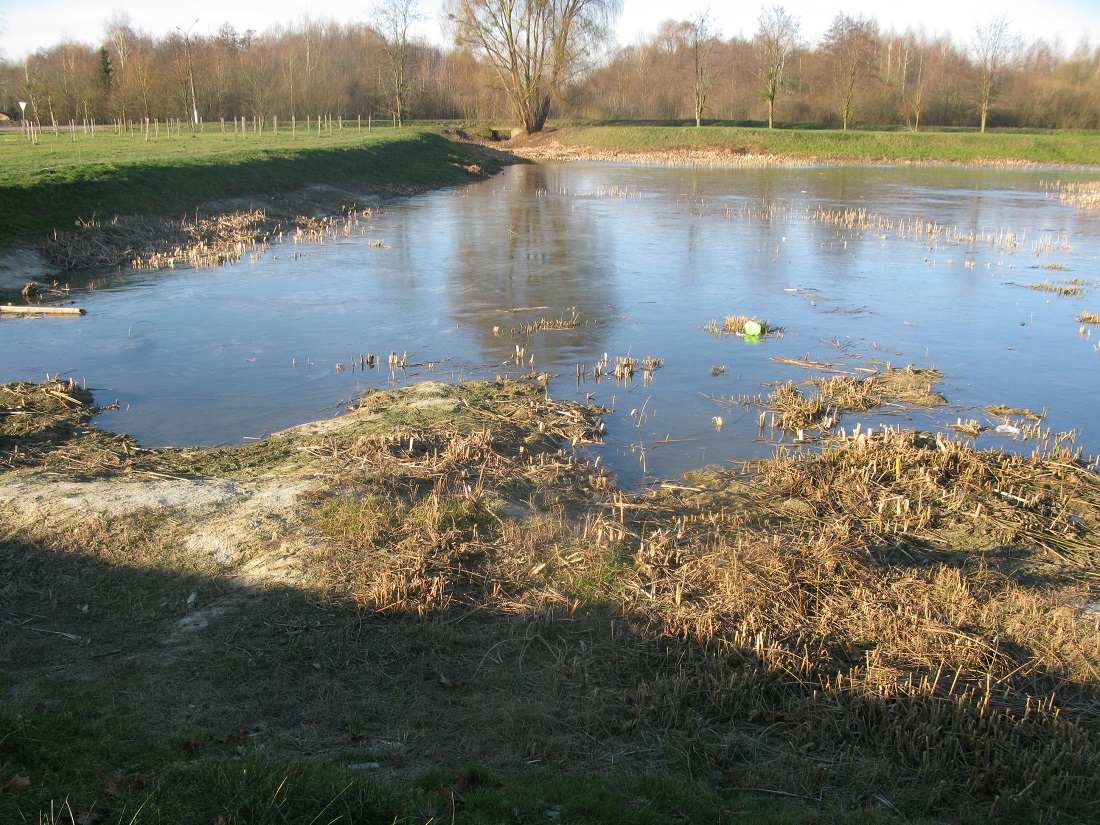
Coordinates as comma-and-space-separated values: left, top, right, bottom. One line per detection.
0, 694, 915, 825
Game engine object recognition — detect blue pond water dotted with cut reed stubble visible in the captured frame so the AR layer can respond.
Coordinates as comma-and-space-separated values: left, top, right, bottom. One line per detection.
0, 164, 1100, 484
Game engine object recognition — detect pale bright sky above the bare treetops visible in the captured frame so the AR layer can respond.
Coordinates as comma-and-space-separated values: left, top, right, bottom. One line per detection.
0, 0, 1100, 61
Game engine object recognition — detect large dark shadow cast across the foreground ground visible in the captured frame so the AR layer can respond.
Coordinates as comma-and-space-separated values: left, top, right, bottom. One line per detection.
0, 514, 1097, 823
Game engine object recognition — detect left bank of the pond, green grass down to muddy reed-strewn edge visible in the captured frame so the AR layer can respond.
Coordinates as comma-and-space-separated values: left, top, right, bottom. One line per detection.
0, 127, 517, 301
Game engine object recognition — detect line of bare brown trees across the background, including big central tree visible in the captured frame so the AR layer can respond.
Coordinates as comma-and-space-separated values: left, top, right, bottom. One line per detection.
0, 0, 1100, 132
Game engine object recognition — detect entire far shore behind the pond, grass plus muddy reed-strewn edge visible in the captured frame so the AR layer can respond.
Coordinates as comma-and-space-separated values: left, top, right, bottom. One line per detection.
0, 124, 1100, 303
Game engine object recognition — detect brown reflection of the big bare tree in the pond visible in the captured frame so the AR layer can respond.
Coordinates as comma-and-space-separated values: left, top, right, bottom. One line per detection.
447, 166, 616, 361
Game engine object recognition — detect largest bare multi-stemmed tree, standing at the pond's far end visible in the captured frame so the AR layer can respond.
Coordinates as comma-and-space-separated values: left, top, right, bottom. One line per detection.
447, 0, 623, 134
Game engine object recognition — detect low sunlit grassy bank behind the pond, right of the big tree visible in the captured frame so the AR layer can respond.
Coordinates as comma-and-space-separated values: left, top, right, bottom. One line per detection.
510, 124, 1100, 166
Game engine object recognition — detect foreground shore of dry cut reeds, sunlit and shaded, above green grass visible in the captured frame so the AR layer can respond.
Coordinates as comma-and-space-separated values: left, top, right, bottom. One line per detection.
0, 378, 1100, 821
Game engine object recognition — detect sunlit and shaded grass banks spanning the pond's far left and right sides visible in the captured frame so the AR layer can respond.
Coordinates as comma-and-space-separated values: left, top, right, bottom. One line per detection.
0, 124, 1100, 251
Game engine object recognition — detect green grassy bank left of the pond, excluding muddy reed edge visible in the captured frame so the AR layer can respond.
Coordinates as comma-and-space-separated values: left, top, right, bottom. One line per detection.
0, 125, 506, 243
